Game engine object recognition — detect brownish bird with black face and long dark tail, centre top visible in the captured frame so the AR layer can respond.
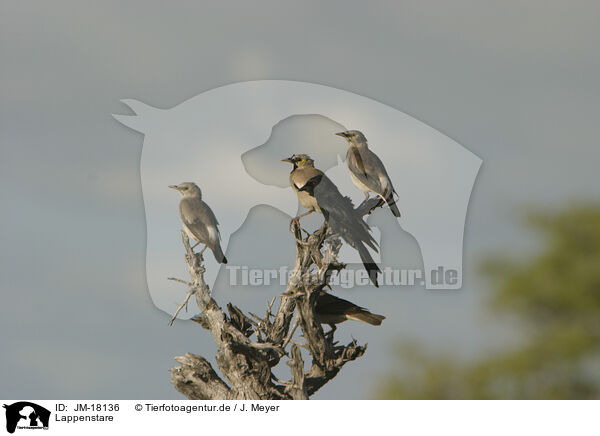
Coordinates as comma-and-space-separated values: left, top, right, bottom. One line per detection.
282, 154, 381, 287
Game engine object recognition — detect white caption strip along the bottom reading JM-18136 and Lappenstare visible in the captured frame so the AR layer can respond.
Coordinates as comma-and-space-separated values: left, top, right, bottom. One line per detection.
2, 400, 600, 436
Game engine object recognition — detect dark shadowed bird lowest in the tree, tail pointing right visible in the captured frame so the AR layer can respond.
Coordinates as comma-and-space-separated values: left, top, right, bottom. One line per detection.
315, 292, 385, 329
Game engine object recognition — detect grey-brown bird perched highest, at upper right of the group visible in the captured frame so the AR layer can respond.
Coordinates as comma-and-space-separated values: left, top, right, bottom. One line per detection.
336, 130, 400, 218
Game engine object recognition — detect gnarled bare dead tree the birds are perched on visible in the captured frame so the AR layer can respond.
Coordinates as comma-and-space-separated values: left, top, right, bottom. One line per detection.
171, 199, 381, 400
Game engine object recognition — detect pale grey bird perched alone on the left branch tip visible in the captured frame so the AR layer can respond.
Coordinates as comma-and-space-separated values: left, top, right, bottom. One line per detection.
169, 182, 227, 263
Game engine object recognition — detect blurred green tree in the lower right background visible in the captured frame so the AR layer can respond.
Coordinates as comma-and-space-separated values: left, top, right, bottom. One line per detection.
377, 206, 600, 399
